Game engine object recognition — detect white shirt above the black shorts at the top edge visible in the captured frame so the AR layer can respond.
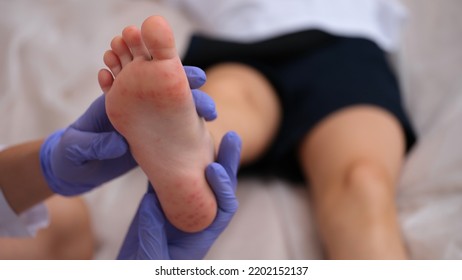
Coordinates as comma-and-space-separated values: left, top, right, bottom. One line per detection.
164, 0, 406, 51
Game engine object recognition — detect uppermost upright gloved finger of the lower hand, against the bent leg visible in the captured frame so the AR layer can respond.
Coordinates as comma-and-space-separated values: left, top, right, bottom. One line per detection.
217, 131, 242, 188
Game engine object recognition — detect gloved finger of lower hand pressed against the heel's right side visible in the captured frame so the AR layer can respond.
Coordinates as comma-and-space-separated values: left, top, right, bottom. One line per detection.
205, 162, 239, 213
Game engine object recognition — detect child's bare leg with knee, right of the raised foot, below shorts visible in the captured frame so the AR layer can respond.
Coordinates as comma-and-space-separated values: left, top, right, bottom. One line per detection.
300, 106, 407, 259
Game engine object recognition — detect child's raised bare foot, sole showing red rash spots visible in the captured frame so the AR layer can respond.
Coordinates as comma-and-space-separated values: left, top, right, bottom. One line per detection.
98, 16, 217, 232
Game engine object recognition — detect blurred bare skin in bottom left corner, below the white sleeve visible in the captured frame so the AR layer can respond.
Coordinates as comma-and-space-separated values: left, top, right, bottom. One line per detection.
0, 196, 94, 260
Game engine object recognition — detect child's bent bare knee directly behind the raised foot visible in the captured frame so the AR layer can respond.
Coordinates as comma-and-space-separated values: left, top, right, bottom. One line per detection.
201, 63, 281, 164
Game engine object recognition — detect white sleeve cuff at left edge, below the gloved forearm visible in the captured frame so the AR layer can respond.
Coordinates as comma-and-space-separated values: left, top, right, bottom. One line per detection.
0, 146, 49, 237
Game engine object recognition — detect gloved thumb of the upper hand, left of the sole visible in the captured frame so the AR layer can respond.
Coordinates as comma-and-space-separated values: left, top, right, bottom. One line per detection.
62, 127, 128, 164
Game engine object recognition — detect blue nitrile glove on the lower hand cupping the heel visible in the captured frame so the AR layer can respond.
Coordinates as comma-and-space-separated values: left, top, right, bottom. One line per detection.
118, 132, 241, 260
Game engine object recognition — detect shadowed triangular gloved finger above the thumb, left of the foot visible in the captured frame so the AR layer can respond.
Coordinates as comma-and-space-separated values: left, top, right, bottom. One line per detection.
71, 94, 115, 132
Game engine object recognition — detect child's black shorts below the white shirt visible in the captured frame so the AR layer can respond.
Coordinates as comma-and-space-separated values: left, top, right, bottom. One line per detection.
183, 30, 415, 180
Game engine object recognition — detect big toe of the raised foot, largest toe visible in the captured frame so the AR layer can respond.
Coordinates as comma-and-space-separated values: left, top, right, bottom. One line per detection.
141, 16, 177, 60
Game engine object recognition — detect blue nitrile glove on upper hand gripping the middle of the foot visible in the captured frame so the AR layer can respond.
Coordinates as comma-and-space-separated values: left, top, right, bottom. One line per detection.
40, 66, 216, 196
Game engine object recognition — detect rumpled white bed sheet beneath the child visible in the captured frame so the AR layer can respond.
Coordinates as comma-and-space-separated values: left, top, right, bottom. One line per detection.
0, 0, 462, 259
